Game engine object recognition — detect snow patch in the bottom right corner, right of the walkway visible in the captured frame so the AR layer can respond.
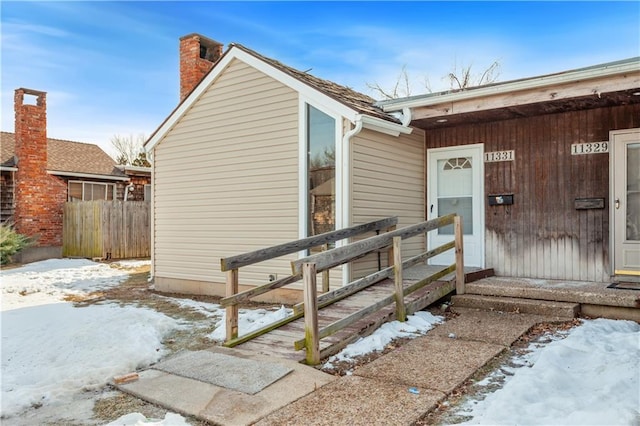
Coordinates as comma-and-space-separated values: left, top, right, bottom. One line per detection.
458, 319, 640, 425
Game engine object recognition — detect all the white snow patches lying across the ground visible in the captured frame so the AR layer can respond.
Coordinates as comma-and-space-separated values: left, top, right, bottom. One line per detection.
0, 259, 640, 425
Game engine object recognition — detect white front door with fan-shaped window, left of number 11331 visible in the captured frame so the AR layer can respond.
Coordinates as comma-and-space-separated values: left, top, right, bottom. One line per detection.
427, 144, 484, 268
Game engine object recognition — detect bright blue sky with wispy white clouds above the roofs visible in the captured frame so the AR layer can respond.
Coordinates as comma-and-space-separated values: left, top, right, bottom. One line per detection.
0, 1, 640, 157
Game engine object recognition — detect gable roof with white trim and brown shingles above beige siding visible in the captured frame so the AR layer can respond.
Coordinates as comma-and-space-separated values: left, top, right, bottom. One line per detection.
144, 43, 412, 150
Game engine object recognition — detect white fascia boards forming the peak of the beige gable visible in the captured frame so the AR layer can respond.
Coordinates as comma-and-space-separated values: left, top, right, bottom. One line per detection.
144, 46, 357, 152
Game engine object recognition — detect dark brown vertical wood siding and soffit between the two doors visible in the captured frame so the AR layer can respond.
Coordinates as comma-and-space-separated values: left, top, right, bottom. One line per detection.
426, 104, 640, 281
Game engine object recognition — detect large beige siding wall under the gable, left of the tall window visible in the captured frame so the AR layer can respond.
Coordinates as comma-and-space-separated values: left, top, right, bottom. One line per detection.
153, 59, 298, 284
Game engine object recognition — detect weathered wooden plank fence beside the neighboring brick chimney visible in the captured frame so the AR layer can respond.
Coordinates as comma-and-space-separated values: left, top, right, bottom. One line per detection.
62, 201, 151, 260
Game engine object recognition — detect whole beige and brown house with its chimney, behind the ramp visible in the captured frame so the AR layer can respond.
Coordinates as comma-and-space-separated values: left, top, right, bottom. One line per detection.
146, 34, 640, 297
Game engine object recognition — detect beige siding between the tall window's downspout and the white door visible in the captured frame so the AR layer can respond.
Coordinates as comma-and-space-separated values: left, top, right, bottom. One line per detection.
351, 129, 425, 279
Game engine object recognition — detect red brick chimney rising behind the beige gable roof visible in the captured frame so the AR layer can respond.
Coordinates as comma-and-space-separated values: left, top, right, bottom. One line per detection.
180, 34, 222, 102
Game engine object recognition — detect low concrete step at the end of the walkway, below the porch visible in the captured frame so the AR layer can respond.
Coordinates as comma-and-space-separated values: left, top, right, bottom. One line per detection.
451, 294, 580, 318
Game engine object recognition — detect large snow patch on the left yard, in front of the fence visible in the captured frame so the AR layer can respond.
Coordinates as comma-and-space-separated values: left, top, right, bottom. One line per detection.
0, 259, 178, 419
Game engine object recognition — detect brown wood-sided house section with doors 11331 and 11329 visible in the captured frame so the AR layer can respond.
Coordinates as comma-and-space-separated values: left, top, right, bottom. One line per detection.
378, 57, 640, 282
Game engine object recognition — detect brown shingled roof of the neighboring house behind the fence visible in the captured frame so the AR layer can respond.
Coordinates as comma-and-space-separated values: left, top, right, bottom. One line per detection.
0, 132, 126, 177
